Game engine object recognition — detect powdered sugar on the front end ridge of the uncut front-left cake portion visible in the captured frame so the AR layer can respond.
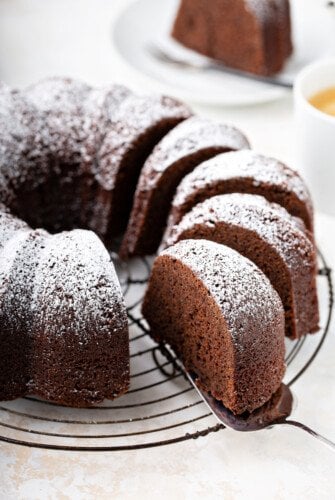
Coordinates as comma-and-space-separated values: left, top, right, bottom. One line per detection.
31, 230, 127, 342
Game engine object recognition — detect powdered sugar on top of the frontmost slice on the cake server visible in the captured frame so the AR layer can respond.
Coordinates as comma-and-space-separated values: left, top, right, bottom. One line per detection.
161, 240, 283, 344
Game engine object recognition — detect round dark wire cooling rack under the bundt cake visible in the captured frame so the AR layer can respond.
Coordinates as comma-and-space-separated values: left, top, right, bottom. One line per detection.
0, 249, 333, 452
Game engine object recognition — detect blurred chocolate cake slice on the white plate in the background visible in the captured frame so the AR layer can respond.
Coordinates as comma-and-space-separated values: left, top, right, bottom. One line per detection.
172, 0, 292, 75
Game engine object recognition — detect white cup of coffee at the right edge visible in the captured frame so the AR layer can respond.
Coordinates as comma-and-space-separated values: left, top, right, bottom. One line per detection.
294, 59, 335, 215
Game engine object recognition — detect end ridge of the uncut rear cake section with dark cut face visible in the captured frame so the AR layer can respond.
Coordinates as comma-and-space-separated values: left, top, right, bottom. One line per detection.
95, 93, 192, 242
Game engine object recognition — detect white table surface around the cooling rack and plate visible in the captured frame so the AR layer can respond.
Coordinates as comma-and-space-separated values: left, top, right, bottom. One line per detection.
0, 0, 335, 500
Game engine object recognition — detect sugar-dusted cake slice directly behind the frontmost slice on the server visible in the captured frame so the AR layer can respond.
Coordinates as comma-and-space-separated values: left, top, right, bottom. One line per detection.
167, 194, 319, 339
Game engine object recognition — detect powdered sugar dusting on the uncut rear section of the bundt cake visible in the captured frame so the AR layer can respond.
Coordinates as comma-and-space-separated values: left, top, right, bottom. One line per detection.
0, 78, 190, 240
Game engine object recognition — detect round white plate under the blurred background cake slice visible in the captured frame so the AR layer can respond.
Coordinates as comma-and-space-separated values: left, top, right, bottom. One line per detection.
113, 0, 335, 106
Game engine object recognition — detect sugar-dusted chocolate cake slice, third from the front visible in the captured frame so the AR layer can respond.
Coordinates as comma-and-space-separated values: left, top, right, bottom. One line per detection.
163, 150, 313, 247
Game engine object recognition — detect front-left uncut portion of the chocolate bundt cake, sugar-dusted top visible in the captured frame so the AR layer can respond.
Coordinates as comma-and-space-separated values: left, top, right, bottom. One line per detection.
0, 206, 129, 407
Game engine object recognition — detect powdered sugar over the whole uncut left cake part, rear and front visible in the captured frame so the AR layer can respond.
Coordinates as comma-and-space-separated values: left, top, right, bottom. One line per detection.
0, 78, 190, 340
